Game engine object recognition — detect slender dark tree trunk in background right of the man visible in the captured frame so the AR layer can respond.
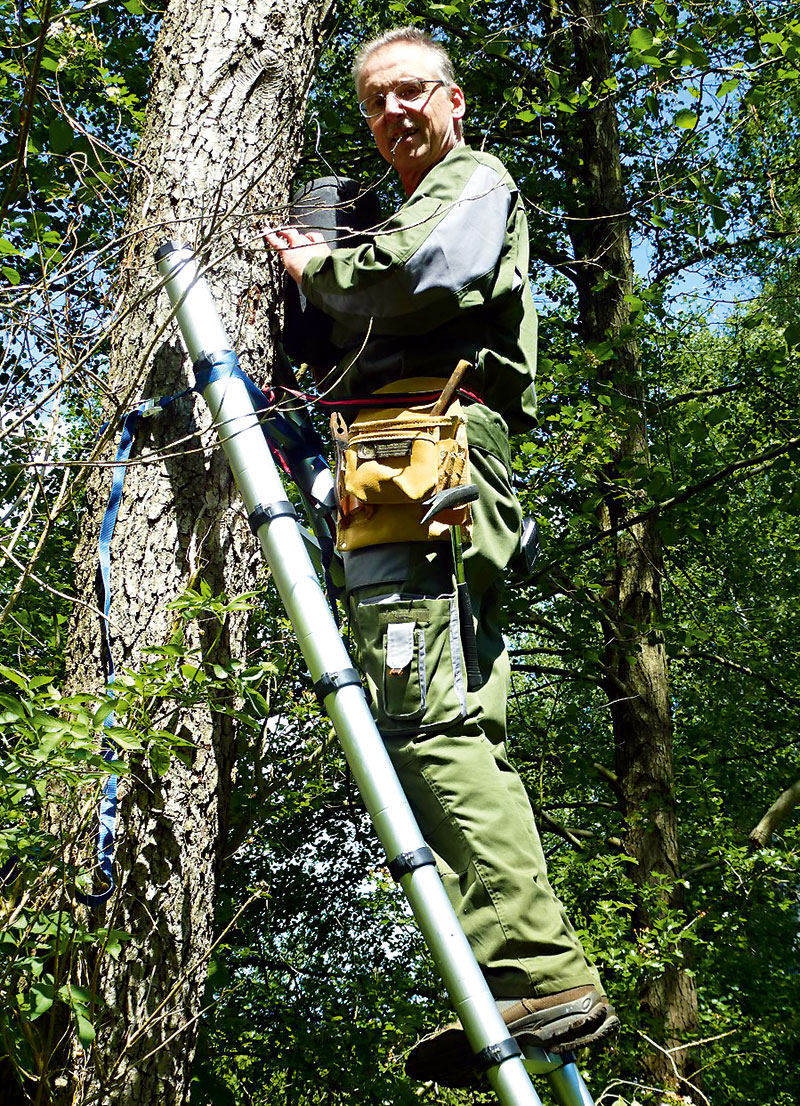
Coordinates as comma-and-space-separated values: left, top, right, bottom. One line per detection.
553, 0, 697, 1093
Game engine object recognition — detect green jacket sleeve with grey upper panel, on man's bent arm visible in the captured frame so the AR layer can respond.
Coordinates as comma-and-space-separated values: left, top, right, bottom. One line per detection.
302, 157, 513, 335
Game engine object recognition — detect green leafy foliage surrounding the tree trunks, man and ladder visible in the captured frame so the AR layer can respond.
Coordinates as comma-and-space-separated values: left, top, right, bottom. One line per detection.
0, 0, 800, 1106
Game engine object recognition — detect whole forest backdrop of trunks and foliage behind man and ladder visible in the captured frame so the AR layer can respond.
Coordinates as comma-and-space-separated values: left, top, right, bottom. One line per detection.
0, 0, 800, 1106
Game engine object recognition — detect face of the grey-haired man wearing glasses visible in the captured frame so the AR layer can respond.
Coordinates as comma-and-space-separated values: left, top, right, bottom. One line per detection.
359, 42, 464, 196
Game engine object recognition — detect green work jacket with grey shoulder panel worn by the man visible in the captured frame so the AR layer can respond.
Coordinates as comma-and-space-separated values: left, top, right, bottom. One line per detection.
302, 146, 537, 438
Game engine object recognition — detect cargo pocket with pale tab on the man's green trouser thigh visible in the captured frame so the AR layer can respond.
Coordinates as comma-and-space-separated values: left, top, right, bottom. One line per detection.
352, 594, 467, 733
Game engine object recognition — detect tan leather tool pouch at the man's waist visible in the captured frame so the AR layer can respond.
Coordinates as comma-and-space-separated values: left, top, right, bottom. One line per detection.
331, 377, 471, 551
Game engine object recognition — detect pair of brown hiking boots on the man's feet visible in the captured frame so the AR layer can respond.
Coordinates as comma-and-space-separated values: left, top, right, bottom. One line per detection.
405, 987, 620, 1087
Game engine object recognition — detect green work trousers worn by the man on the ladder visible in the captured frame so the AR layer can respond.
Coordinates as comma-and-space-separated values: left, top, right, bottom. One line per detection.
345, 411, 600, 999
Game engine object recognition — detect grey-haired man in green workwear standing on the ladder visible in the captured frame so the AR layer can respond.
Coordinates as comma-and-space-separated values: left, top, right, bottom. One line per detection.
267, 28, 619, 1086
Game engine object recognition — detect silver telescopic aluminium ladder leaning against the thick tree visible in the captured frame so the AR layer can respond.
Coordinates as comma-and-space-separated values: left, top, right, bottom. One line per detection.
156, 242, 594, 1106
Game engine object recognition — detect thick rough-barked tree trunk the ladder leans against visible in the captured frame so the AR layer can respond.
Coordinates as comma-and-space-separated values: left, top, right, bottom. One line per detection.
58, 0, 331, 1106
